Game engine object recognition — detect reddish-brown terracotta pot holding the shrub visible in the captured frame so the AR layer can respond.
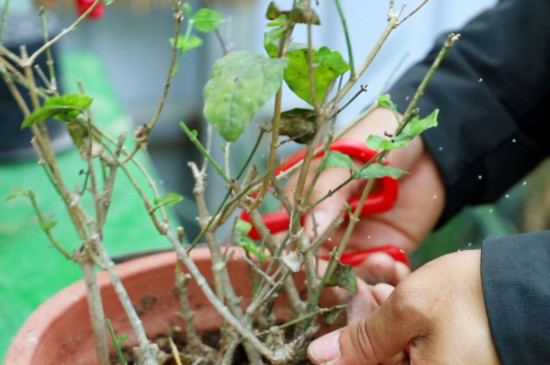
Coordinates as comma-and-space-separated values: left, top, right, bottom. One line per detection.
4, 248, 306, 365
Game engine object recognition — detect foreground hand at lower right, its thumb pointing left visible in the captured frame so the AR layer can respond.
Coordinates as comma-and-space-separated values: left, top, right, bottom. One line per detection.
308, 250, 499, 365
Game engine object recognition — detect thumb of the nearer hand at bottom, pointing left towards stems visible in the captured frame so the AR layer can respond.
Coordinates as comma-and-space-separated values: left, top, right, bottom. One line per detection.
307, 288, 423, 365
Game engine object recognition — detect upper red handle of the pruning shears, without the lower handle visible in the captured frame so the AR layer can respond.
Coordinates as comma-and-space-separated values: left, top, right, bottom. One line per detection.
241, 140, 398, 240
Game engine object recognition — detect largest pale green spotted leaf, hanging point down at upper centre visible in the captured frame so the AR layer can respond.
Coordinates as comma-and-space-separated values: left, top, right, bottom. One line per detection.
204, 51, 288, 142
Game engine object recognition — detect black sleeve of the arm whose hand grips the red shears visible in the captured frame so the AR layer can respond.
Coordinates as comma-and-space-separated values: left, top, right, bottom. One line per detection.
390, 0, 550, 223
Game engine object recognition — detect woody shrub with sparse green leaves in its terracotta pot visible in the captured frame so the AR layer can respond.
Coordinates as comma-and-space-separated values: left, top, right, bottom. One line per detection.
0, 0, 457, 364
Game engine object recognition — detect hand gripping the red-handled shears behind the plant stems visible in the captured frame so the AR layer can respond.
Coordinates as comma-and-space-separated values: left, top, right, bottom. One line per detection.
285, 108, 444, 284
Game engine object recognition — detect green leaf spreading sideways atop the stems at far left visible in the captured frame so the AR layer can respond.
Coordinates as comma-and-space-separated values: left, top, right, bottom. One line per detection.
21, 94, 93, 129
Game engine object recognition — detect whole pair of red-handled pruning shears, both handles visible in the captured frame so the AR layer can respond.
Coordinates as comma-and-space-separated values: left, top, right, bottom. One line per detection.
240, 140, 410, 266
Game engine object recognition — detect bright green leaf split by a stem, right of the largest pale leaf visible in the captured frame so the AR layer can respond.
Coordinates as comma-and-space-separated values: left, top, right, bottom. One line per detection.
284, 47, 349, 104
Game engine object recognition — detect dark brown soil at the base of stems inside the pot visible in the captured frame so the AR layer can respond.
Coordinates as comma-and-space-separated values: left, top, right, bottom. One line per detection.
111, 331, 313, 365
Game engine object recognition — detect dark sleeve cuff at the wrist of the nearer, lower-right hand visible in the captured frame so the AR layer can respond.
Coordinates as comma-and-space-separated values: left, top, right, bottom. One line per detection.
481, 231, 550, 364
